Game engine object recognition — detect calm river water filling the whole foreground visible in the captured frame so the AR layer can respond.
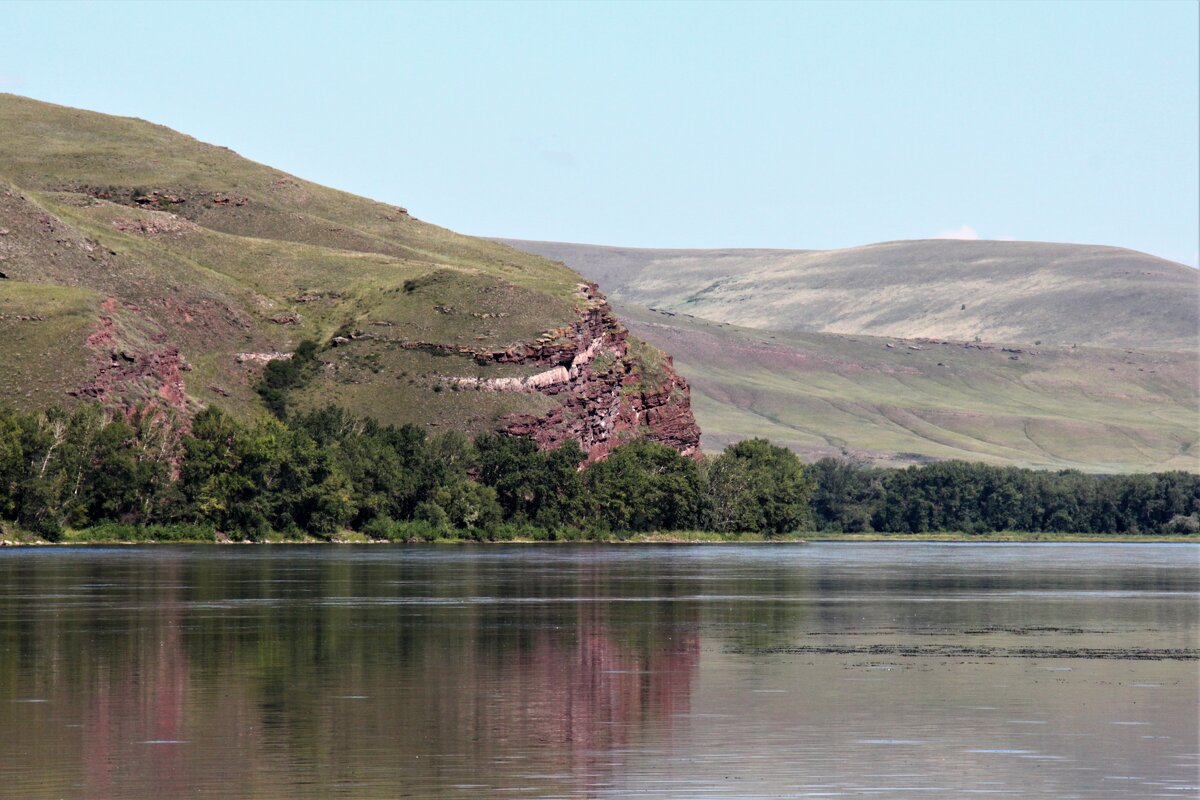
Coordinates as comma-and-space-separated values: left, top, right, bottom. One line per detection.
0, 543, 1200, 800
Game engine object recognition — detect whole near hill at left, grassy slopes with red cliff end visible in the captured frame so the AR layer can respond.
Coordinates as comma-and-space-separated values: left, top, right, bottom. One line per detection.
0, 95, 698, 457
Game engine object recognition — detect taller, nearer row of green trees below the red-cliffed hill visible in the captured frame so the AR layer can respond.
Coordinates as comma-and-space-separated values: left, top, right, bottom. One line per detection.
0, 405, 812, 541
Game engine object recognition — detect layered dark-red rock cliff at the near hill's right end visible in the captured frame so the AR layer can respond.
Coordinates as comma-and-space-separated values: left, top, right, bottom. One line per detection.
489, 284, 700, 461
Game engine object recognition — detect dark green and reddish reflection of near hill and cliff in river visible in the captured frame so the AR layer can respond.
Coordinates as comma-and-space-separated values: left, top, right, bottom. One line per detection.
0, 558, 700, 799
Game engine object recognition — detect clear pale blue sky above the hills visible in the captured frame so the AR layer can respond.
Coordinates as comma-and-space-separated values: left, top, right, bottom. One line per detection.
0, 0, 1200, 266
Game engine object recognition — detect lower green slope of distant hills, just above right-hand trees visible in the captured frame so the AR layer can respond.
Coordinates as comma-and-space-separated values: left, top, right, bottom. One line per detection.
618, 306, 1200, 473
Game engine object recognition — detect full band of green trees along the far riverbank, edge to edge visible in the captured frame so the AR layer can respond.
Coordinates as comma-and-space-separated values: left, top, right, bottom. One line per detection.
0, 405, 1200, 542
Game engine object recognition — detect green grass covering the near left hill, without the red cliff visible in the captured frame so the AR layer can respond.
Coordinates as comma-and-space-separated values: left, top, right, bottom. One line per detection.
0, 94, 587, 429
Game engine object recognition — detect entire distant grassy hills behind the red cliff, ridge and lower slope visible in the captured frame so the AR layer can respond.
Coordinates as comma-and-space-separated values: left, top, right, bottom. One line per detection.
499, 241, 1200, 473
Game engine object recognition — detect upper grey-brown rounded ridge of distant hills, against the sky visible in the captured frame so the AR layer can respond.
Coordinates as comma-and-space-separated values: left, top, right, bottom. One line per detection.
509, 240, 1200, 351
